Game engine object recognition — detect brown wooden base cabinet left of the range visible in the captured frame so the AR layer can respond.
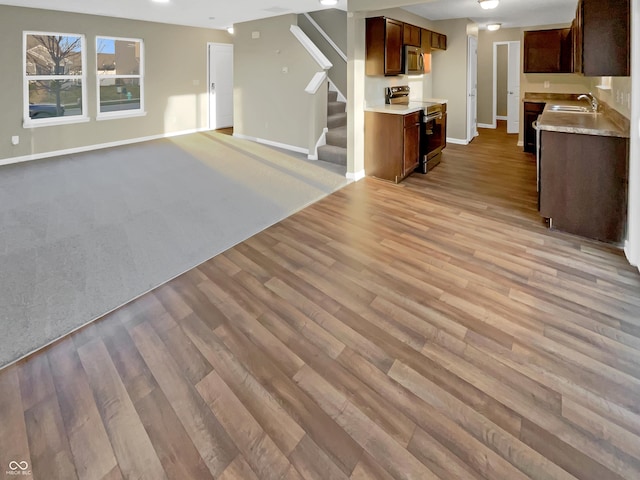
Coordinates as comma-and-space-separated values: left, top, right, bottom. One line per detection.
364, 111, 422, 183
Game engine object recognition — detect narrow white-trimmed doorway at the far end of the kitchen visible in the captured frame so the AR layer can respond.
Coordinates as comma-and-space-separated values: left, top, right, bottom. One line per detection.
493, 41, 520, 133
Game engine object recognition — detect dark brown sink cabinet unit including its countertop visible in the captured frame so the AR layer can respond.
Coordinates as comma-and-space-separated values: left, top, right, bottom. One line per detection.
537, 94, 629, 244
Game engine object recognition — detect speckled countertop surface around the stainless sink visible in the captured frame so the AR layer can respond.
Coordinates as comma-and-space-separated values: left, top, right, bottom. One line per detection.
524, 95, 629, 138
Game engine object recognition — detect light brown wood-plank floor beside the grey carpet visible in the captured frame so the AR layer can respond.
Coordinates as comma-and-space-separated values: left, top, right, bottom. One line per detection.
0, 124, 640, 480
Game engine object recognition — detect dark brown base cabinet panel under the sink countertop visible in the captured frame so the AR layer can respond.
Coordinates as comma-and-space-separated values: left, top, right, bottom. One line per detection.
540, 130, 629, 243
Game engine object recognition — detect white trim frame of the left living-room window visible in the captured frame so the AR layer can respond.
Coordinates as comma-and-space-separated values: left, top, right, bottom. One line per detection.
22, 31, 89, 128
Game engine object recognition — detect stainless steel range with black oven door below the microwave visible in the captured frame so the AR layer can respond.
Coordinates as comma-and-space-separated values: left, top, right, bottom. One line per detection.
384, 85, 447, 173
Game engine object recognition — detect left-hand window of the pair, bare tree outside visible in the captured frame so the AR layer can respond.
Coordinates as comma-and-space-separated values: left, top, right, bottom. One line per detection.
24, 32, 88, 127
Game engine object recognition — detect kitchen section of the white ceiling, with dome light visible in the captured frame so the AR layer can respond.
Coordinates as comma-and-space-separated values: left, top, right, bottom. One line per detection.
404, 0, 578, 29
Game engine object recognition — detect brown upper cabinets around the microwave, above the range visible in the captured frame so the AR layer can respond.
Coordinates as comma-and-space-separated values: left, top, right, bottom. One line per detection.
365, 17, 447, 75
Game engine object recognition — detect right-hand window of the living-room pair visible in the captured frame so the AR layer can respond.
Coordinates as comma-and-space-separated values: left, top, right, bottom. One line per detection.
96, 37, 144, 119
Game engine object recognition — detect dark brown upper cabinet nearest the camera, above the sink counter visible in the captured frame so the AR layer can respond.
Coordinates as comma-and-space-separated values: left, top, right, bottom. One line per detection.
574, 0, 631, 77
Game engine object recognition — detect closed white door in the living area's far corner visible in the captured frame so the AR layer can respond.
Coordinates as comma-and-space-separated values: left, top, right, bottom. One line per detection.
209, 43, 233, 130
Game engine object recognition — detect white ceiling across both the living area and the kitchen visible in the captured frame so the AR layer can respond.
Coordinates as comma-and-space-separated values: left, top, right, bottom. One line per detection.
0, 0, 577, 29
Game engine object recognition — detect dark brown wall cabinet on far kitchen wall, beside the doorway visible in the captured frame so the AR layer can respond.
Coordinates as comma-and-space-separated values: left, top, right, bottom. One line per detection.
524, 28, 573, 73
